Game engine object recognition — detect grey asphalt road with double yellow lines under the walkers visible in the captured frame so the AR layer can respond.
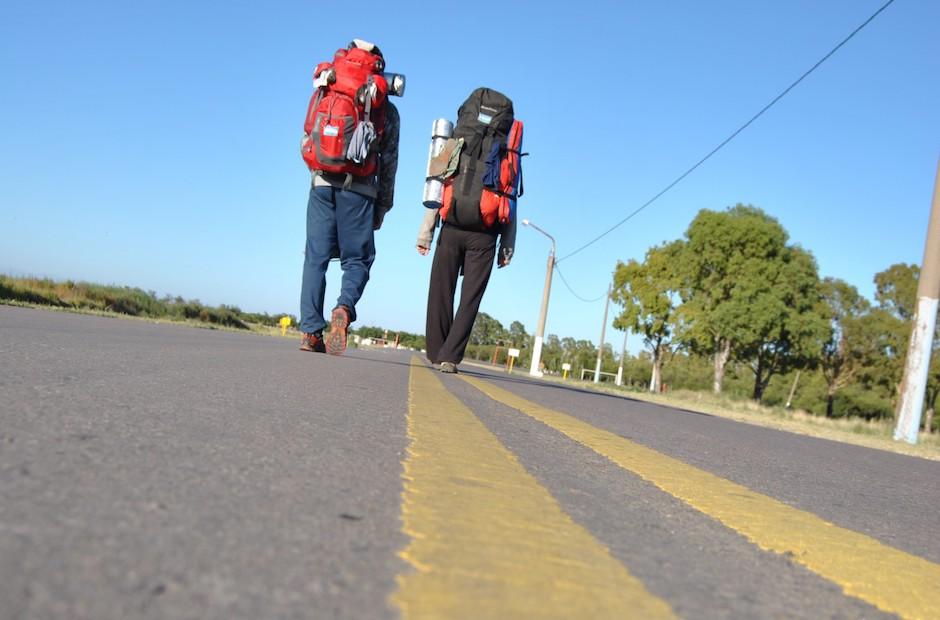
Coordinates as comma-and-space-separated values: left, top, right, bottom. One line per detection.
0, 306, 940, 620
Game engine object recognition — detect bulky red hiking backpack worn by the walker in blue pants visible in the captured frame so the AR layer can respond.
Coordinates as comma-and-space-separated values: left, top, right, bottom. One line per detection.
300, 44, 388, 177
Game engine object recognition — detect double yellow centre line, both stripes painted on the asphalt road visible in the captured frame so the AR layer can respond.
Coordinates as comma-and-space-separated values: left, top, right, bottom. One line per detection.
392, 359, 940, 619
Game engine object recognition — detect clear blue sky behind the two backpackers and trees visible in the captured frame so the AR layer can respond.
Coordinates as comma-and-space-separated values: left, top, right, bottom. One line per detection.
0, 0, 940, 350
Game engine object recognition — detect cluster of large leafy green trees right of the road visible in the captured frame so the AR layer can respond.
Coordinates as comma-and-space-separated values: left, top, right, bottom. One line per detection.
614, 204, 928, 426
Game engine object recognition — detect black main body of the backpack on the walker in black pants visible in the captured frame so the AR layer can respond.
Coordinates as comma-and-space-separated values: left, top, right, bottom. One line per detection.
443, 88, 514, 231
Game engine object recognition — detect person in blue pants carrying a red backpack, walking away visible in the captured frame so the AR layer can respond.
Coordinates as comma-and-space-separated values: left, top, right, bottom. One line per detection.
300, 39, 404, 355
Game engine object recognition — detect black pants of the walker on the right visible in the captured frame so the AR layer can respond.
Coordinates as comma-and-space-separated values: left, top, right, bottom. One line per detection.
425, 224, 497, 364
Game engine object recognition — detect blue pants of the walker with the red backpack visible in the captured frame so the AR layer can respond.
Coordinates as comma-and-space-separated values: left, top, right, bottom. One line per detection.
300, 187, 375, 333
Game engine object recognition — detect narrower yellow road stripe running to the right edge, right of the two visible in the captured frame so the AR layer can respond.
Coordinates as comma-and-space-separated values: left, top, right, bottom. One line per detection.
462, 376, 940, 618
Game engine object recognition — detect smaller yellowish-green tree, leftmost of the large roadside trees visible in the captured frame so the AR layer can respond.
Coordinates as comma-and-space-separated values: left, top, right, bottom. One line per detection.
612, 241, 684, 392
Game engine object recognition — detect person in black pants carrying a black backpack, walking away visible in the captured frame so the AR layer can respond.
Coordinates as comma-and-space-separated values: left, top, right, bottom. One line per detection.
417, 88, 522, 373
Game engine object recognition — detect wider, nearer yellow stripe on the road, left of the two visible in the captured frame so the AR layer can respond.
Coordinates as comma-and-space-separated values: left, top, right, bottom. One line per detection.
391, 358, 674, 620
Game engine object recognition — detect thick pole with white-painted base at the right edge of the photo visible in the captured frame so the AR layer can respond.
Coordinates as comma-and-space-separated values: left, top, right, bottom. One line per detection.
894, 160, 940, 444
